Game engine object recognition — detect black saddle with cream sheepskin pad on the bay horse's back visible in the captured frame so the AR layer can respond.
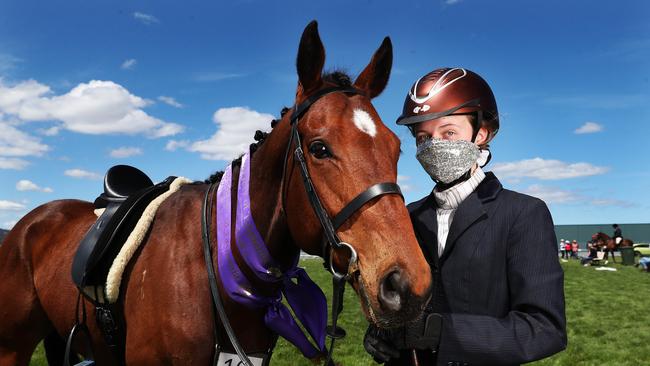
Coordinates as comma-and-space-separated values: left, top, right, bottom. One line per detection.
72, 165, 191, 304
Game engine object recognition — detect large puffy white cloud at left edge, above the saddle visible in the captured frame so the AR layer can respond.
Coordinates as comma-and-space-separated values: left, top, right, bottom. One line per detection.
0, 80, 183, 138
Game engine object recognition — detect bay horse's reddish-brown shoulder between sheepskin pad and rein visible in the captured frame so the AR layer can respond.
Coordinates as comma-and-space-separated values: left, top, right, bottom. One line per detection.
124, 185, 212, 364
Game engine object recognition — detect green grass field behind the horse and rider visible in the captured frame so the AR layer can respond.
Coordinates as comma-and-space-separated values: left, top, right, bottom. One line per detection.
31, 260, 650, 366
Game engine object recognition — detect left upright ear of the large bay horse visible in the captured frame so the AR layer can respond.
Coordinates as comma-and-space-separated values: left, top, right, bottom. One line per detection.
296, 20, 325, 95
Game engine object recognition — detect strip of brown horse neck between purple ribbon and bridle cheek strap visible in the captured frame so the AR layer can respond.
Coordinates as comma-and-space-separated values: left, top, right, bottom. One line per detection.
250, 118, 299, 268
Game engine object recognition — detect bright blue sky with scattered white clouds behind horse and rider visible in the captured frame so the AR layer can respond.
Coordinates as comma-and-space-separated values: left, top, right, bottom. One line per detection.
0, 0, 650, 228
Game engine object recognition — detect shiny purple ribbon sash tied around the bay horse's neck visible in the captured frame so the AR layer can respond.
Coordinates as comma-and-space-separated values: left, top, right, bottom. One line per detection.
217, 153, 327, 358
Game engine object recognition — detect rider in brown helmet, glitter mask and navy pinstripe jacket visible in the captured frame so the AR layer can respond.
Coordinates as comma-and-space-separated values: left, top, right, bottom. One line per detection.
364, 68, 567, 365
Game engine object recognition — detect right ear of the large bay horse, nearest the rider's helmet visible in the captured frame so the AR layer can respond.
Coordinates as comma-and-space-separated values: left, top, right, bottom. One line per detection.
354, 37, 393, 99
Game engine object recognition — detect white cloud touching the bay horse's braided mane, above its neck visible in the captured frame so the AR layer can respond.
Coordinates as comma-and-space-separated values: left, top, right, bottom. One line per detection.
187, 107, 274, 160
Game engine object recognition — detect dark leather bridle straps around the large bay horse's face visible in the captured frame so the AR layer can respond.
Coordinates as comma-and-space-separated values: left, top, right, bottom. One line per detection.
282, 87, 404, 365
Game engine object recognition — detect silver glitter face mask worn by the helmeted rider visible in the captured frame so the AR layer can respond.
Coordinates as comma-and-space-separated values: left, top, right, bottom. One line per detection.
415, 139, 480, 183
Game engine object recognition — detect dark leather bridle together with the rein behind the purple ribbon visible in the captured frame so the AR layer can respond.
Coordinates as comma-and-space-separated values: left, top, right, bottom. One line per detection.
202, 86, 403, 366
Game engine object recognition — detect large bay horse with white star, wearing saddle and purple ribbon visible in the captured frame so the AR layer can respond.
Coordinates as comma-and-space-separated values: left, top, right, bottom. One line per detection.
0, 22, 431, 366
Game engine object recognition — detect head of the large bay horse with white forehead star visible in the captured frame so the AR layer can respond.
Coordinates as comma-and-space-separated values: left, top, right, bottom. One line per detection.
251, 22, 431, 327
